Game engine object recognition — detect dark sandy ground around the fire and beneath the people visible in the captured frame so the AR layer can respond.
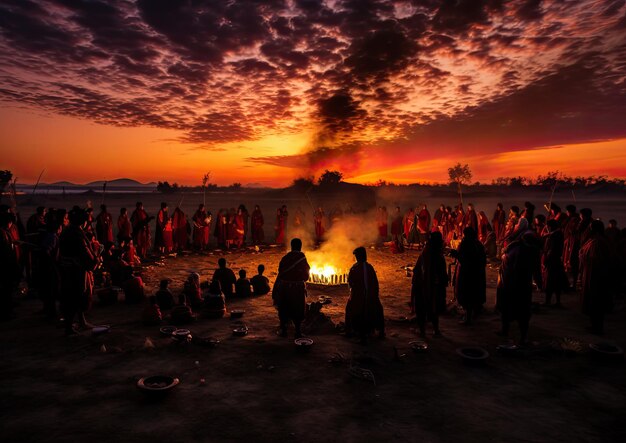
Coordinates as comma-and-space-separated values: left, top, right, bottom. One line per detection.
0, 243, 626, 442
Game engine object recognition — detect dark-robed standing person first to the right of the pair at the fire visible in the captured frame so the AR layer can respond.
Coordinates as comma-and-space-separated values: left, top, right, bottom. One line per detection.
411, 231, 448, 337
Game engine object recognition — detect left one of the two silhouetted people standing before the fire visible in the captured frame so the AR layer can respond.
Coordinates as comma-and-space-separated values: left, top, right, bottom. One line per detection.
272, 238, 311, 338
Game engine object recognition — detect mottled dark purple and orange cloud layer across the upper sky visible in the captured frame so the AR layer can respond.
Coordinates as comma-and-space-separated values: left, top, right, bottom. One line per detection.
0, 0, 626, 179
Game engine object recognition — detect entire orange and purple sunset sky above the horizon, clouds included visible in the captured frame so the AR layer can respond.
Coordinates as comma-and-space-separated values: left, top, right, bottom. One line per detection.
0, 0, 626, 186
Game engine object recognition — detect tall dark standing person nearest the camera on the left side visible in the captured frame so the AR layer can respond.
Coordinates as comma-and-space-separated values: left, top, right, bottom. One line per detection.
59, 207, 98, 335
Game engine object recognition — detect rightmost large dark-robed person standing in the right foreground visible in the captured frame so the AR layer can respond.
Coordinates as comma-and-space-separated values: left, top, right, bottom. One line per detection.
580, 220, 615, 335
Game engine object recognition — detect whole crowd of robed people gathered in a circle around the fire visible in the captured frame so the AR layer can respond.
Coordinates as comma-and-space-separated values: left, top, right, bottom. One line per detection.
0, 202, 626, 343
